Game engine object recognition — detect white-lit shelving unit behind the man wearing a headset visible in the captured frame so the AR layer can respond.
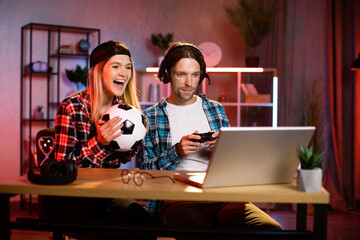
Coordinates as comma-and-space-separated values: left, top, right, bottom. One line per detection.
140, 67, 278, 127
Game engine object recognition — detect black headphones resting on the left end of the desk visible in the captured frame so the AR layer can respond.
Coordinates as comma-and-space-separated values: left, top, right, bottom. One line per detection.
27, 128, 77, 185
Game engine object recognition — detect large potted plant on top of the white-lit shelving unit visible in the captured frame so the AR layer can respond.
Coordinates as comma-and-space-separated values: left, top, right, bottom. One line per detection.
225, 0, 280, 67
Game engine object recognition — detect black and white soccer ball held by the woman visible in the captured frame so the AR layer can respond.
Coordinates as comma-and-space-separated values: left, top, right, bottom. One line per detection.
101, 104, 146, 152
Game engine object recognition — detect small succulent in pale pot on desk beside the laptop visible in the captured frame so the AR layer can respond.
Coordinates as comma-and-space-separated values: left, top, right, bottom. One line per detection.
297, 145, 323, 192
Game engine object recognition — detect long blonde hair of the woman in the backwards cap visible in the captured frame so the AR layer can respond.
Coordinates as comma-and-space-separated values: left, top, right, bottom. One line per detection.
88, 57, 141, 124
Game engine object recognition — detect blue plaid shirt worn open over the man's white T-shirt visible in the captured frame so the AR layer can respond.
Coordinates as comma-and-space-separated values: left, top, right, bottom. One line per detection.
139, 94, 229, 216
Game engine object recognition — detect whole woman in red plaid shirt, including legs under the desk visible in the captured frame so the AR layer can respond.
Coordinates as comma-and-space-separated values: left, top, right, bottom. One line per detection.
55, 41, 152, 239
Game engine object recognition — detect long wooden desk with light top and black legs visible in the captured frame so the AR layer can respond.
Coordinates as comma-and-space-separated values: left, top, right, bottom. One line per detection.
0, 169, 329, 240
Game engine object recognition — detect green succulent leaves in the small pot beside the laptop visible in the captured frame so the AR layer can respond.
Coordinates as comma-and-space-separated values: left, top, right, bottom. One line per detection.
297, 145, 323, 169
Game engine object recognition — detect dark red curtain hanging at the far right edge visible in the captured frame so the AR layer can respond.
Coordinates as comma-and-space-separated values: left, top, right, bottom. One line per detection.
324, 0, 360, 211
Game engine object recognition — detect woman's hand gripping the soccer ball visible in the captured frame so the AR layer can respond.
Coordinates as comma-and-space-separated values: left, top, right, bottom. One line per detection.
96, 117, 123, 145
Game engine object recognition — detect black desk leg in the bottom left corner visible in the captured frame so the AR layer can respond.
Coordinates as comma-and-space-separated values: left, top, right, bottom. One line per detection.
0, 194, 11, 240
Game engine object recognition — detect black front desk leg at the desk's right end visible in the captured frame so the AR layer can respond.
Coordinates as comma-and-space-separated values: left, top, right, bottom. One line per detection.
314, 204, 328, 240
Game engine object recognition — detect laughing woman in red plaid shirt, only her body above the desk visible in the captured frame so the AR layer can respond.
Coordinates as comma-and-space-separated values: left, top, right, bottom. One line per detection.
55, 41, 141, 168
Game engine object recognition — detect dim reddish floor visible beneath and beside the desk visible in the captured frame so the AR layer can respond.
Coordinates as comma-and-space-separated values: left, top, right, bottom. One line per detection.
10, 197, 360, 240
